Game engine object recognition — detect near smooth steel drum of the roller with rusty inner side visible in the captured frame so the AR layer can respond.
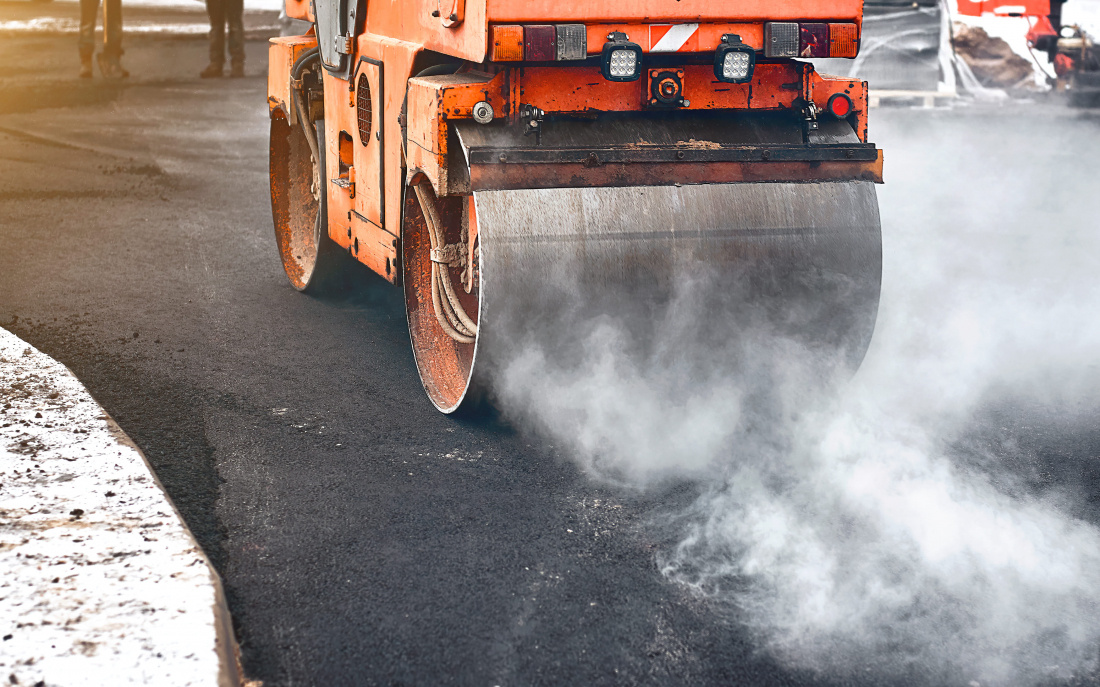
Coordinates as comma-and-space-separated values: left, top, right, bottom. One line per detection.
404, 181, 882, 412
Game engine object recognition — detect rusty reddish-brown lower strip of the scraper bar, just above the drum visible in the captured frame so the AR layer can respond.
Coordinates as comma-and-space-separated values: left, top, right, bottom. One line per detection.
470, 151, 882, 191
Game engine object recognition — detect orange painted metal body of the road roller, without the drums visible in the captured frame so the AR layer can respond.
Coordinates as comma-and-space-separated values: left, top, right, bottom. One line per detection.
268, 0, 881, 282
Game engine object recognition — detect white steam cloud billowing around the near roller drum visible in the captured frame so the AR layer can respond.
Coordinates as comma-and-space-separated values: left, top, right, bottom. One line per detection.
493, 114, 1100, 685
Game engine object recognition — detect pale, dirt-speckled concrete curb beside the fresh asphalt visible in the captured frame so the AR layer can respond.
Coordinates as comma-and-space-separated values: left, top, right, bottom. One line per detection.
0, 329, 242, 687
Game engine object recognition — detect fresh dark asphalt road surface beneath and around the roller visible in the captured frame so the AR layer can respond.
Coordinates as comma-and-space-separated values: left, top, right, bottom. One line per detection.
0, 26, 1100, 686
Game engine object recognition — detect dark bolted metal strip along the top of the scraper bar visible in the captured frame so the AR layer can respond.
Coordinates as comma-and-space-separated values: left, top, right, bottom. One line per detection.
470, 143, 879, 166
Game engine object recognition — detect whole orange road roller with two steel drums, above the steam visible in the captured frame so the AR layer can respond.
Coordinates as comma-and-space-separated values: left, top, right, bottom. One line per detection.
268, 0, 882, 412
